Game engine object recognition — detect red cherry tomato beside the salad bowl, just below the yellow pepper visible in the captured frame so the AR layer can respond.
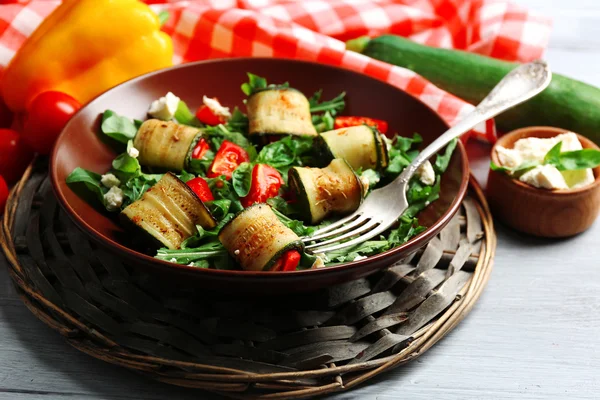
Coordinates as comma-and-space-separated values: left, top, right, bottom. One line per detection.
23, 92, 81, 154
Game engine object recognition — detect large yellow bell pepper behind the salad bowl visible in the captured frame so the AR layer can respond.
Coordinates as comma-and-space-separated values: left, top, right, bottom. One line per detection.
1, 0, 173, 112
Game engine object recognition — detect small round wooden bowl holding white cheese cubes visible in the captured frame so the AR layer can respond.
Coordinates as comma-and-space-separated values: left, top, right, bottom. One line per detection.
487, 126, 600, 237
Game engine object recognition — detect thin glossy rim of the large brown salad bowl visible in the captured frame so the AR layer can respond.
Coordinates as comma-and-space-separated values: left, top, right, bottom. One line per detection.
49, 57, 470, 279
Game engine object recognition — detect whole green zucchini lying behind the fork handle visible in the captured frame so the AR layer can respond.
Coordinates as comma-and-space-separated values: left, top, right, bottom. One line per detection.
348, 35, 600, 144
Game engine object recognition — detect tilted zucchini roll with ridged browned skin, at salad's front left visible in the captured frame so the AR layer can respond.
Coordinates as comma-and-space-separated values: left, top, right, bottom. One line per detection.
121, 172, 217, 249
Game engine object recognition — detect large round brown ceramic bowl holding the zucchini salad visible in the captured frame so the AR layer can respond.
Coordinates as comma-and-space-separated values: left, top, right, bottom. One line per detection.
51, 58, 469, 293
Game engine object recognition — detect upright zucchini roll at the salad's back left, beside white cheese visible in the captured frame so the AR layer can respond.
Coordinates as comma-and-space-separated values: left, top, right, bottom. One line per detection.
133, 119, 202, 172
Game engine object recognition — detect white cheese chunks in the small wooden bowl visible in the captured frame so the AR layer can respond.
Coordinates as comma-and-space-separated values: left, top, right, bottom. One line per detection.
496, 132, 594, 189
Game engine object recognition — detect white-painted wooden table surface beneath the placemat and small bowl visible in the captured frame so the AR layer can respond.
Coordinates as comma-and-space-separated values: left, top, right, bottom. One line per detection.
0, 0, 600, 400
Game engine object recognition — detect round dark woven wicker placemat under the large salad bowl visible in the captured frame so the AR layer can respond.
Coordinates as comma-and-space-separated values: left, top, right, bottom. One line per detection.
0, 162, 496, 399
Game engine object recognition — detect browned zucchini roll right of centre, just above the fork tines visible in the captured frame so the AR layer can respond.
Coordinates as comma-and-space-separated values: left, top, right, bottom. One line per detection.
288, 158, 365, 224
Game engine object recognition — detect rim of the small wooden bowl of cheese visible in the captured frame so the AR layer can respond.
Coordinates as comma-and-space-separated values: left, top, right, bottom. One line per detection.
490, 125, 600, 197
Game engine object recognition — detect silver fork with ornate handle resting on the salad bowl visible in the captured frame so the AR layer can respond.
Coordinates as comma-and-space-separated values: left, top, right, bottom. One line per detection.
302, 60, 552, 253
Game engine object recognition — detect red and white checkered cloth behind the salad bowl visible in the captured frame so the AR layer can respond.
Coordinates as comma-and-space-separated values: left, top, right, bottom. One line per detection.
0, 0, 551, 140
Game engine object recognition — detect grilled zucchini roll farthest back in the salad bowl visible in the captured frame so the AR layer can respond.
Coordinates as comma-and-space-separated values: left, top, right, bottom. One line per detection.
246, 87, 317, 136
